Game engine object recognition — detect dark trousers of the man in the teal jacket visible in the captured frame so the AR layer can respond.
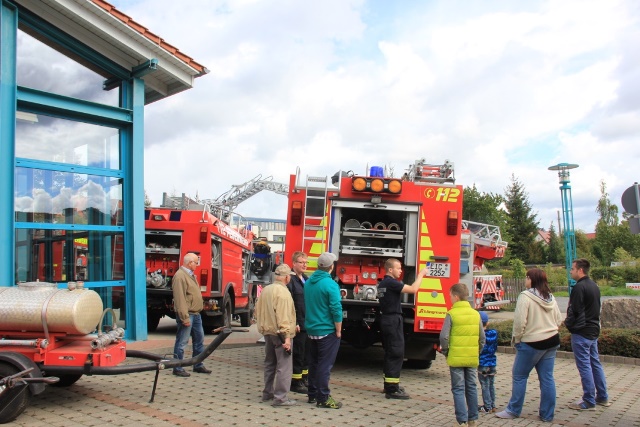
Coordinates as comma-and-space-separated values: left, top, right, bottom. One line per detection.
307, 333, 340, 403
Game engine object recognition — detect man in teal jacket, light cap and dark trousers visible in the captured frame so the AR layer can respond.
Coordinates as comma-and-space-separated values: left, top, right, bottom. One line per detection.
304, 252, 342, 409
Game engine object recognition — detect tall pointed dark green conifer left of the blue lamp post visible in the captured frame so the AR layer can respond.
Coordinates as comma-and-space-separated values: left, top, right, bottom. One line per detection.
504, 174, 538, 263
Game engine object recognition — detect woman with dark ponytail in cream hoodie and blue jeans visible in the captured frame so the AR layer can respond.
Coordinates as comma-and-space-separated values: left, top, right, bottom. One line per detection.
496, 268, 562, 422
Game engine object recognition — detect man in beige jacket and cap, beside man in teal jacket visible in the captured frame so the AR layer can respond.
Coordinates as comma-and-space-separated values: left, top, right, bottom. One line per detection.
255, 264, 297, 406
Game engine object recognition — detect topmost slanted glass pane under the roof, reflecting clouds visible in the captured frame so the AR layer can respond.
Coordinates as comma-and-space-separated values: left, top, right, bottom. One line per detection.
16, 31, 120, 107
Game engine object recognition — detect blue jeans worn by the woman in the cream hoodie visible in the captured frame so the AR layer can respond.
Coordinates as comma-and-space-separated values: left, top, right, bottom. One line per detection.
507, 342, 560, 421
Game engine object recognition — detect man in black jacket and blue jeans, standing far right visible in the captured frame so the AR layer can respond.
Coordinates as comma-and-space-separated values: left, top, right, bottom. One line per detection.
564, 258, 610, 411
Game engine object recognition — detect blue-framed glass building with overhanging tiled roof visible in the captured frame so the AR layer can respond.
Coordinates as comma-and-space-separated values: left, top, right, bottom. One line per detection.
0, 0, 206, 340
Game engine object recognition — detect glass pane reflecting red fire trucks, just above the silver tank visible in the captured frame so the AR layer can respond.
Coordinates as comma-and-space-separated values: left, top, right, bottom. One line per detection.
16, 229, 125, 283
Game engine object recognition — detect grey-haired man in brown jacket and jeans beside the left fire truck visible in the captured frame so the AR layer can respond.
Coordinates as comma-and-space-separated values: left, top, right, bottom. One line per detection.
171, 253, 211, 377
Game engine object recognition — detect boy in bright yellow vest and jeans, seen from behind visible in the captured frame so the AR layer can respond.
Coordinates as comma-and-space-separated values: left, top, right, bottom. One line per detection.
440, 283, 485, 426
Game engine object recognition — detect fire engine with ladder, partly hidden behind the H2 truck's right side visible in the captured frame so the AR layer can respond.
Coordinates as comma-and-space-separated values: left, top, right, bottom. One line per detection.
460, 220, 510, 310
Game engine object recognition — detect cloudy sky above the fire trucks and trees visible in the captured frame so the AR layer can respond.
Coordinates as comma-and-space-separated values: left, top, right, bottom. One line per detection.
110, 0, 640, 232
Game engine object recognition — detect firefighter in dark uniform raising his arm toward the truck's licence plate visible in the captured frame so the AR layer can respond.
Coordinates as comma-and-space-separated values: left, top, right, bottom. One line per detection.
378, 258, 428, 399
